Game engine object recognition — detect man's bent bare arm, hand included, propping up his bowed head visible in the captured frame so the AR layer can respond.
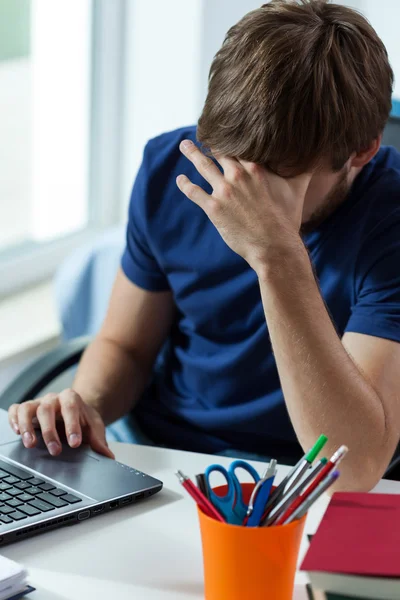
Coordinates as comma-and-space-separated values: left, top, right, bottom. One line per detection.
177, 140, 400, 490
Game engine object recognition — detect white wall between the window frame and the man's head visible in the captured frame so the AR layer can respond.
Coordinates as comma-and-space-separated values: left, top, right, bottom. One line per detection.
122, 0, 260, 213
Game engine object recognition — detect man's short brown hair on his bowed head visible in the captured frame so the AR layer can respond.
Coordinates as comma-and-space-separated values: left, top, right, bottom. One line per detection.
197, 0, 393, 174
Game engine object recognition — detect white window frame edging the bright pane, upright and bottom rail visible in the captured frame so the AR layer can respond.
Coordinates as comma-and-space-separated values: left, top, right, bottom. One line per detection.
0, 0, 127, 298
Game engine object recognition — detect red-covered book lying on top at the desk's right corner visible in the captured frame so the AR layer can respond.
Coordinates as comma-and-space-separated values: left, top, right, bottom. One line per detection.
301, 492, 400, 600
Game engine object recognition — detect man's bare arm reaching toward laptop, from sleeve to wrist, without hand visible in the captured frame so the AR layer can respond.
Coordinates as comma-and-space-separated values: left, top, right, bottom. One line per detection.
73, 270, 175, 424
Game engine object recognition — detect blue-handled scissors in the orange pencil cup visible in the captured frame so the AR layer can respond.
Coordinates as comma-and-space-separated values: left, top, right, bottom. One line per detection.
204, 460, 260, 525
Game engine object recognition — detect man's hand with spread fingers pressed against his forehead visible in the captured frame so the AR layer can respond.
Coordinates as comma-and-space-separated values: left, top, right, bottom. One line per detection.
176, 140, 311, 272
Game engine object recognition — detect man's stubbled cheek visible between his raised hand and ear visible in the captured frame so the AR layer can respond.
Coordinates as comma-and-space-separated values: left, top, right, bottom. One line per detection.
301, 164, 357, 233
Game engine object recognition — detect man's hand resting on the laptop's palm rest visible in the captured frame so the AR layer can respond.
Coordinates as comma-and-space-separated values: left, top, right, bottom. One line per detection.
8, 390, 115, 458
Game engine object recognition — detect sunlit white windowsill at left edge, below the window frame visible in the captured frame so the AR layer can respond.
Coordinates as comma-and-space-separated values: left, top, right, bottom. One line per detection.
0, 282, 61, 363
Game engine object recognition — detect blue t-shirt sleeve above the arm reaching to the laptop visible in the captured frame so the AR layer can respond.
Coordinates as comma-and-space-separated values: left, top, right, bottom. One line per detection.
121, 145, 170, 292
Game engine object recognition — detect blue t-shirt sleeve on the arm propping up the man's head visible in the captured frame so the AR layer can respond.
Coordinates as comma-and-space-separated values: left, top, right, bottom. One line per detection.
346, 216, 400, 342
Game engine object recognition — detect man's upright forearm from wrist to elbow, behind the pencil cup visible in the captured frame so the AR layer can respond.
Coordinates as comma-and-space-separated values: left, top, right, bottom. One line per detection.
259, 238, 387, 489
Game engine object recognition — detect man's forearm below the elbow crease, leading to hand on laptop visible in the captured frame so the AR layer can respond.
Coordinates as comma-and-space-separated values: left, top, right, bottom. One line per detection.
73, 337, 150, 425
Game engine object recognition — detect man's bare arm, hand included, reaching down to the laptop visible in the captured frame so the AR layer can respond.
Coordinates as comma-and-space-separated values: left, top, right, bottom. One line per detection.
8, 270, 174, 457
